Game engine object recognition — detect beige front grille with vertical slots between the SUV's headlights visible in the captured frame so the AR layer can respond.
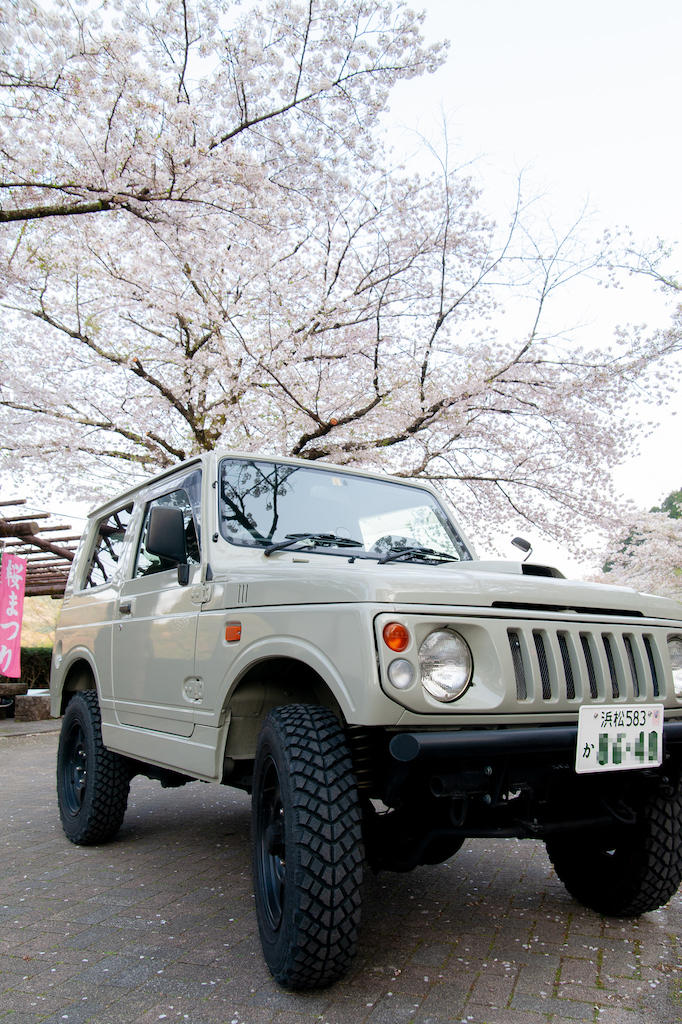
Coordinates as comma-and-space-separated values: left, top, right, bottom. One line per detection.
507, 623, 665, 705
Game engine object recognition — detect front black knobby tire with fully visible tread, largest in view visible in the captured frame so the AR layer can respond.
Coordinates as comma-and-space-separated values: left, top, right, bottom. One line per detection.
252, 705, 365, 990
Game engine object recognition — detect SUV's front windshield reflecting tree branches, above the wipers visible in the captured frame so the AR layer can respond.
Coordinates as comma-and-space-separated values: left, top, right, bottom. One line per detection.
219, 459, 471, 560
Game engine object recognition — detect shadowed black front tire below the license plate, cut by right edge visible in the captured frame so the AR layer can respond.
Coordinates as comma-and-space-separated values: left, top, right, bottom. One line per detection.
547, 787, 682, 918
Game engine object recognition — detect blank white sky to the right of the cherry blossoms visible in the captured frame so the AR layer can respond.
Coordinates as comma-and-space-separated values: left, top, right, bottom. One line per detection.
385, 0, 682, 544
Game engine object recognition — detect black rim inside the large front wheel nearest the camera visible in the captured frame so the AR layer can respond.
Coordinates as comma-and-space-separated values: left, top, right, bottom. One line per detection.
258, 757, 286, 932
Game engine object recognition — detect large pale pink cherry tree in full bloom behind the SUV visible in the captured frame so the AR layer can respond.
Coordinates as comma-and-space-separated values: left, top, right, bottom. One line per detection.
0, 0, 679, 552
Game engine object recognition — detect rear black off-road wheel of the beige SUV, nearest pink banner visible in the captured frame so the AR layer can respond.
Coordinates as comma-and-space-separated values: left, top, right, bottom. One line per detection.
57, 690, 130, 846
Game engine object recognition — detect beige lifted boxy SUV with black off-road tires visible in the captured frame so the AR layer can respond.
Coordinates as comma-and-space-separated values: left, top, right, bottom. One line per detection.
51, 454, 682, 988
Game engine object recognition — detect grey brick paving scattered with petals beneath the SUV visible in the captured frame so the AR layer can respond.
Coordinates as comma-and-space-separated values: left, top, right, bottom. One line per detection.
0, 733, 682, 1024
